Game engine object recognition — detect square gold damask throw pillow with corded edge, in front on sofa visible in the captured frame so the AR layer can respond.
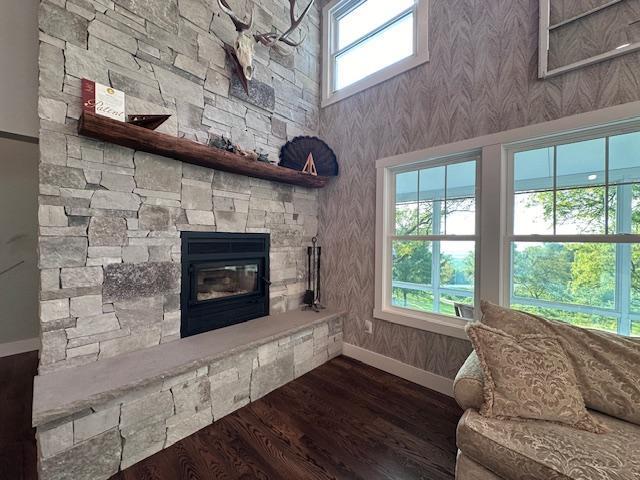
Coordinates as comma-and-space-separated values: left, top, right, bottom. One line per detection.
467, 323, 606, 433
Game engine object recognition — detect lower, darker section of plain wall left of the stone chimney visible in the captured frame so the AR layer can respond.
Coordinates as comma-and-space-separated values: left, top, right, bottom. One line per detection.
0, 137, 39, 344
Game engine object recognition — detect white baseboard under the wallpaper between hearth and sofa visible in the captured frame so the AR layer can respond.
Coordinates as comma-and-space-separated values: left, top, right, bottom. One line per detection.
342, 343, 453, 397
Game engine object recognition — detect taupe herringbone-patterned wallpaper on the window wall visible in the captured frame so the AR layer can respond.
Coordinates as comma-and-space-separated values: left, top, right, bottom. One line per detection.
320, 0, 640, 377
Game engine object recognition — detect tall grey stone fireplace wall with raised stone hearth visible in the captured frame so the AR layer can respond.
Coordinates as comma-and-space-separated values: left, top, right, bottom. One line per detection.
33, 0, 342, 480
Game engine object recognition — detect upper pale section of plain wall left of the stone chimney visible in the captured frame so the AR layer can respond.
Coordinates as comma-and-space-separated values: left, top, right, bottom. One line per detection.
0, 0, 38, 137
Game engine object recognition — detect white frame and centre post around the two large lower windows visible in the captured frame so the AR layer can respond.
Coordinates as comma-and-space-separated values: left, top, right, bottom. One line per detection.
373, 102, 640, 338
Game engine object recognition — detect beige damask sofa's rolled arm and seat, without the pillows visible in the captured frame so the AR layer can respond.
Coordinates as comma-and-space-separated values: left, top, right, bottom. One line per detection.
454, 352, 640, 480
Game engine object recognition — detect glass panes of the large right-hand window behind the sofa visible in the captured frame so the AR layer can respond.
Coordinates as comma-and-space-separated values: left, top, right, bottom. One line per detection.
510, 132, 640, 335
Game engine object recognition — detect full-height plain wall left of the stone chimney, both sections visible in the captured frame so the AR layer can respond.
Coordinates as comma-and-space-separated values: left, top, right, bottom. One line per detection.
0, 0, 39, 346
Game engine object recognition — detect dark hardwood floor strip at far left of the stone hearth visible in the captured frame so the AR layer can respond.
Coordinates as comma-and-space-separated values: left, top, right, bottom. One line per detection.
0, 352, 38, 480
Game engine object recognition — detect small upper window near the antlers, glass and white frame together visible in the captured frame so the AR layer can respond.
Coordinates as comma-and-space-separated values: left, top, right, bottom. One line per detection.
323, 0, 428, 105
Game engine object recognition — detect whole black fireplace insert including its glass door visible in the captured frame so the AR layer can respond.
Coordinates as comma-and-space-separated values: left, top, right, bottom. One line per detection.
180, 232, 270, 337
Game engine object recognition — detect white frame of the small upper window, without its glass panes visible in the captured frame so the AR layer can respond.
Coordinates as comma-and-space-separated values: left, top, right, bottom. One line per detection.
321, 0, 429, 107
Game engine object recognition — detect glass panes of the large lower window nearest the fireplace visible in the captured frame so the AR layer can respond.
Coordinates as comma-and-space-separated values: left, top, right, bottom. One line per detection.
389, 158, 477, 315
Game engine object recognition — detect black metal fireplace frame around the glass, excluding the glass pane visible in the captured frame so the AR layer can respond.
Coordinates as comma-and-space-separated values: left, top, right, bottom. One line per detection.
180, 232, 270, 338
